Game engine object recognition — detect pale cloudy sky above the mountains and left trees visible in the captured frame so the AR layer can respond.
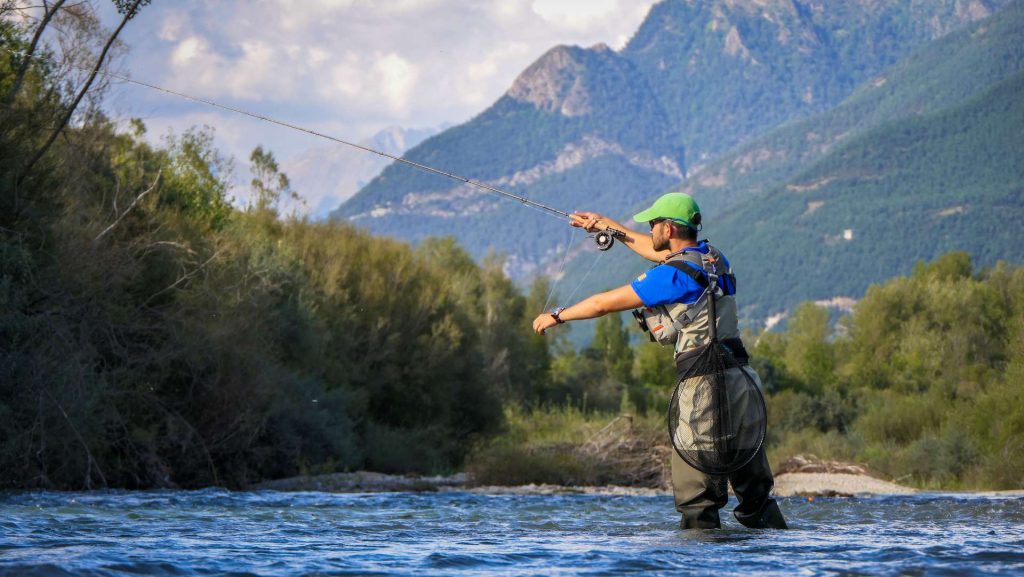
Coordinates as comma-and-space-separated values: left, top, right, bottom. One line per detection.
96, 0, 654, 198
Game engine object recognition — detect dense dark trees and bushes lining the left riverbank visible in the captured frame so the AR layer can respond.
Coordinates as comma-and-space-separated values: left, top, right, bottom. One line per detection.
0, 14, 528, 488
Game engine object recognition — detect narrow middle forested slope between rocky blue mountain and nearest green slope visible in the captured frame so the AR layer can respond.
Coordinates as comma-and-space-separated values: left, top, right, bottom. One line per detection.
682, 2, 1024, 216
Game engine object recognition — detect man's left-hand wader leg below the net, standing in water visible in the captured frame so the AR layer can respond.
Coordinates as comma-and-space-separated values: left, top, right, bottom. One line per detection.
672, 451, 729, 529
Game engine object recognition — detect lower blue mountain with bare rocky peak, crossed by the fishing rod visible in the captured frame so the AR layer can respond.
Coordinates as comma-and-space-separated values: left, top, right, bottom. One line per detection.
334, 45, 685, 274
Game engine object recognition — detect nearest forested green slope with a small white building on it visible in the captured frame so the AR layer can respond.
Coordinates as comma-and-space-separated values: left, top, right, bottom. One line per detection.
715, 73, 1024, 319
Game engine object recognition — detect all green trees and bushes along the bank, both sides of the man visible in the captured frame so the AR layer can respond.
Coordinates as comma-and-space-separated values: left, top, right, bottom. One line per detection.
0, 4, 1024, 489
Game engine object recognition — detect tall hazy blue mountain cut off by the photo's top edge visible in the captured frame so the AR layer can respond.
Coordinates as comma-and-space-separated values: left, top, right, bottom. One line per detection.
623, 0, 1007, 166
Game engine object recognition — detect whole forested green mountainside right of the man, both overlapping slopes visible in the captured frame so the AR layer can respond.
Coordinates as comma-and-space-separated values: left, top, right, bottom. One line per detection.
566, 2, 1024, 327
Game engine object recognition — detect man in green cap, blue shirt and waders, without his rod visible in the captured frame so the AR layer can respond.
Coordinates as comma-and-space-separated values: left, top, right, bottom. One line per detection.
534, 193, 786, 529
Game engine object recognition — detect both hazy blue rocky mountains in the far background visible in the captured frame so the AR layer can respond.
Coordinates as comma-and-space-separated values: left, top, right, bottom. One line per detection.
332, 0, 1006, 277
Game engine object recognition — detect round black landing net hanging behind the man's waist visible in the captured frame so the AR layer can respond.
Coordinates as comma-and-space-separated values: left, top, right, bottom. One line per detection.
669, 339, 767, 475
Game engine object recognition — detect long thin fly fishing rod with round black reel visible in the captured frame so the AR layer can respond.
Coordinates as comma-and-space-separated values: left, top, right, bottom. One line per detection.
2, 47, 626, 250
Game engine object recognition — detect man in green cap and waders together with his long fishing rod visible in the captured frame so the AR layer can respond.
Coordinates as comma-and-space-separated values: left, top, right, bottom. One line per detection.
44, 49, 785, 528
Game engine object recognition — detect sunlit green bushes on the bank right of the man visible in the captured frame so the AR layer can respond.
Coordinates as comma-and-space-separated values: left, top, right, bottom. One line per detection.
755, 252, 1024, 488
